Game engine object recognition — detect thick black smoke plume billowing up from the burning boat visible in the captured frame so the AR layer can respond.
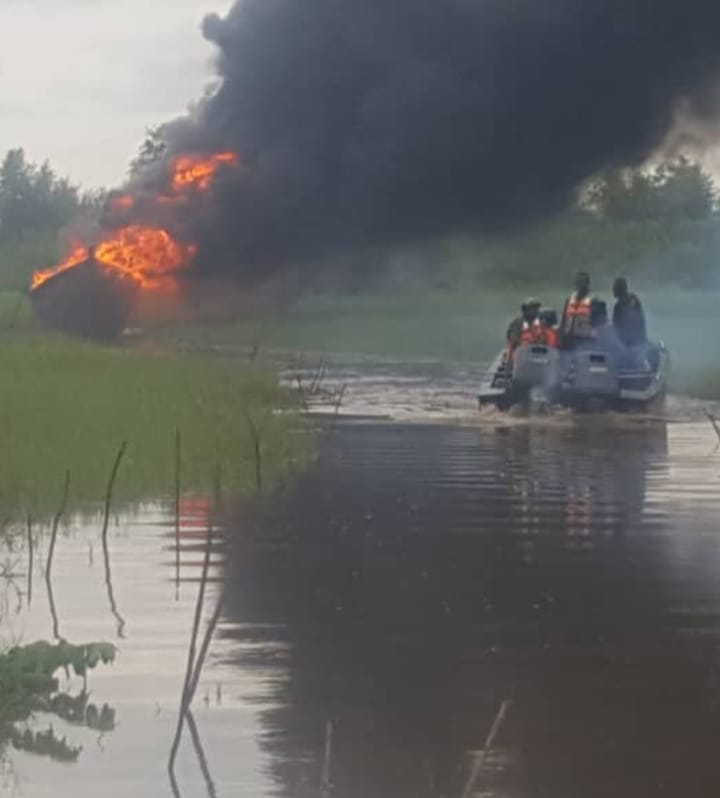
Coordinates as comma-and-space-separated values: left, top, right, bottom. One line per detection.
143, 0, 720, 277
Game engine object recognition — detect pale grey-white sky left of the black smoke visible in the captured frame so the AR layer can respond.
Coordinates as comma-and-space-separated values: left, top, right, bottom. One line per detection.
0, 0, 231, 188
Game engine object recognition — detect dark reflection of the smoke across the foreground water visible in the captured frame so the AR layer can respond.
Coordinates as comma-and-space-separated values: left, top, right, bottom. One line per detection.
226, 425, 720, 798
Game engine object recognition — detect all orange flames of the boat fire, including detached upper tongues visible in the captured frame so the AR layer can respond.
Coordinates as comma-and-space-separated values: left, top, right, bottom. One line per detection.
30, 152, 240, 291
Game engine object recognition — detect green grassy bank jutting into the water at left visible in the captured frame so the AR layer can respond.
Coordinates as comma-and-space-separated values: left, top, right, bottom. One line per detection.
0, 334, 308, 516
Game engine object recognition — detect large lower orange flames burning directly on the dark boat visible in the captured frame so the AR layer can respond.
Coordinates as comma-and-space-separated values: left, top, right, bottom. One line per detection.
31, 225, 195, 290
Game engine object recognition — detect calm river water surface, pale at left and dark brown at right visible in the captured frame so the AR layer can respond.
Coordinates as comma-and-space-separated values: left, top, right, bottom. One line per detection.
0, 365, 720, 798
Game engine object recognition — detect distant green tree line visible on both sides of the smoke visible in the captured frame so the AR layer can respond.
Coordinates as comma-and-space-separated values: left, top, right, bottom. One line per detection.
0, 145, 720, 287
